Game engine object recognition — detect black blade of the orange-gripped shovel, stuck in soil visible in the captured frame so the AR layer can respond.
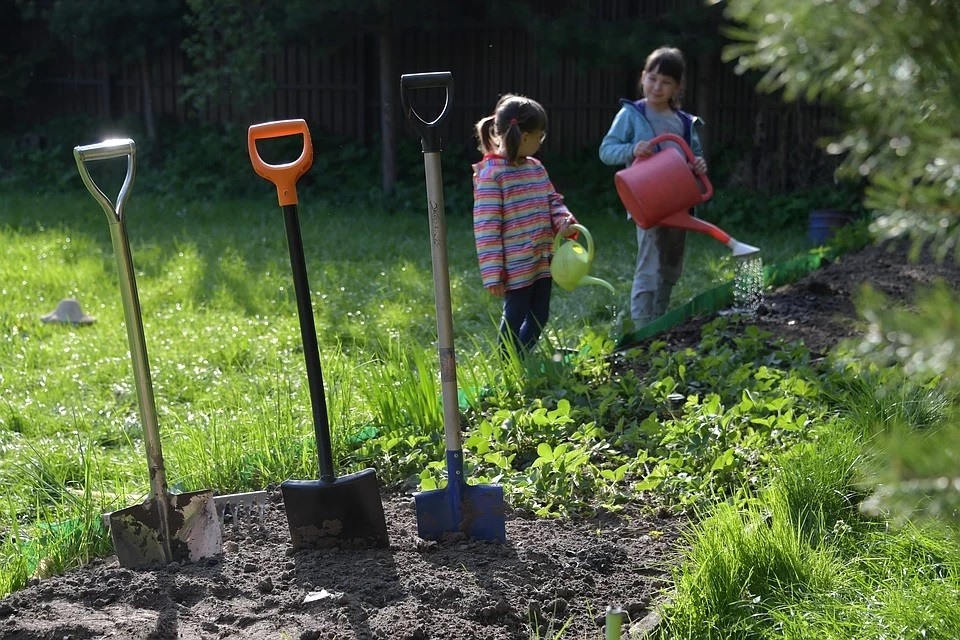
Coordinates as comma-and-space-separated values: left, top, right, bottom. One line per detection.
280, 469, 390, 549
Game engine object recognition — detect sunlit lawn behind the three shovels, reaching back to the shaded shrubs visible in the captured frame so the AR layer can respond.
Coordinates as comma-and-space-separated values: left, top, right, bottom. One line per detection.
0, 180, 805, 592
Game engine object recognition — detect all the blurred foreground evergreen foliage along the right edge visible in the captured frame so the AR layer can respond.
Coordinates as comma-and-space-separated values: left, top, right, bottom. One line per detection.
725, 0, 960, 521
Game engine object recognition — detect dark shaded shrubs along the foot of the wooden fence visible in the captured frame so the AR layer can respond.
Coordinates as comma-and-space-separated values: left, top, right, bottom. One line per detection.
0, 116, 863, 233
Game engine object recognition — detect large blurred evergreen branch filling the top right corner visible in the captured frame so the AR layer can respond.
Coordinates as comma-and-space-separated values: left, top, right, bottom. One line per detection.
725, 0, 960, 251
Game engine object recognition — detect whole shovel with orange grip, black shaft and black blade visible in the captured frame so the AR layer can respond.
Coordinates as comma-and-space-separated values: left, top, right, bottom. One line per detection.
247, 120, 390, 549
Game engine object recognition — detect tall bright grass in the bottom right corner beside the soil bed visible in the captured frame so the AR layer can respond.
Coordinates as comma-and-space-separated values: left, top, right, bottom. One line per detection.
660, 410, 960, 640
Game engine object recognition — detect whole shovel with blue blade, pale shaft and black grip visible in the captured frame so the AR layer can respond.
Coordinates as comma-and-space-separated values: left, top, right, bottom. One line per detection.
400, 71, 506, 542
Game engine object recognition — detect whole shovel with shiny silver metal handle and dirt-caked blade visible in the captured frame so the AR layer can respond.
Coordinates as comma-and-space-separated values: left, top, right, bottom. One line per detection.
73, 139, 222, 568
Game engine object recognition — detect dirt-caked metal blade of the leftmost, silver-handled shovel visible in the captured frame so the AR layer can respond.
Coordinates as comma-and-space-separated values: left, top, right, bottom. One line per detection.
110, 491, 223, 569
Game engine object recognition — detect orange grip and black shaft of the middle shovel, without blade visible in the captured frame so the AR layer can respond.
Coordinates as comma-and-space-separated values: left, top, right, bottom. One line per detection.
247, 120, 336, 482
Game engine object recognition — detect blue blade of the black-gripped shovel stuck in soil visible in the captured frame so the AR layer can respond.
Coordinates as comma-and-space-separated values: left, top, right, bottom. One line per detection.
413, 482, 507, 542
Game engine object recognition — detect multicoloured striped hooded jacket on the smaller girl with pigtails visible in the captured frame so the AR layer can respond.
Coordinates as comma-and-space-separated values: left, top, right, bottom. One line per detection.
473, 154, 570, 291
